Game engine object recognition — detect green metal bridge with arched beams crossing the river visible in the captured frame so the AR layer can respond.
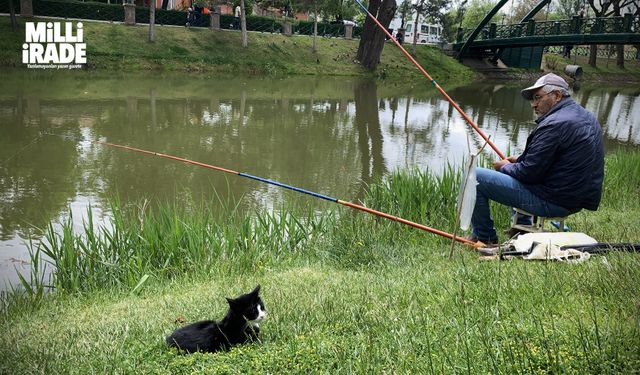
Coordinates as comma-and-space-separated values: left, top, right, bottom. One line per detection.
452, 0, 640, 65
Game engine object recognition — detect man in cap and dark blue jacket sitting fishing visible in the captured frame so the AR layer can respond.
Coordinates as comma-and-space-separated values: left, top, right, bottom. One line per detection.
468, 73, 604, 246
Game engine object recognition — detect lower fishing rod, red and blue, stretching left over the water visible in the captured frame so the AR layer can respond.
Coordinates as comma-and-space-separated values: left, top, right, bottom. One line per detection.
94, 141, 476, 246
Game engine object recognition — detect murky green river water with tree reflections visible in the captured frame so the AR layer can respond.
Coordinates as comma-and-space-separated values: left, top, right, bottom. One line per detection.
0, 72, 640, 290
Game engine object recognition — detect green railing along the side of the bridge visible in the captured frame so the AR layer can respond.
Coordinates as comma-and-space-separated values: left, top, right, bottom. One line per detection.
457, 14, 640, 43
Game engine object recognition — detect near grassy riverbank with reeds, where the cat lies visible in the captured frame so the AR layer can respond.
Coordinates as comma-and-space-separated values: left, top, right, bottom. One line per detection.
0, 152, 640, 374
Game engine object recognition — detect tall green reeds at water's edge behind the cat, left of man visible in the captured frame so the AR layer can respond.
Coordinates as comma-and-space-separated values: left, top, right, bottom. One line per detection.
23, 195, 333, 298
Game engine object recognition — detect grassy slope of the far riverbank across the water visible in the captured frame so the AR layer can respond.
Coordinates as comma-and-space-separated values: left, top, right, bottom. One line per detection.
0, 17, 475, 82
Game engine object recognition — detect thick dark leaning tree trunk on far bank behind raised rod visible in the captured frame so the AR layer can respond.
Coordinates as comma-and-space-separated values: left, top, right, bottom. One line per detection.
356, 0, 396, 70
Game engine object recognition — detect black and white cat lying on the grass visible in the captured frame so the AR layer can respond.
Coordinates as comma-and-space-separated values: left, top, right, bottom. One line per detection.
167, 285, 267, 353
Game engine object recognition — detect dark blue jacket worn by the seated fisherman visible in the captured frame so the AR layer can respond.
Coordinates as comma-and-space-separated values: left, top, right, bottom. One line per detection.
500, 97, 604, 212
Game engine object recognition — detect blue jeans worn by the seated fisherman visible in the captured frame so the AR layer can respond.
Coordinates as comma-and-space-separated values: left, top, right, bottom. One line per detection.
471, 168, 571, 240
